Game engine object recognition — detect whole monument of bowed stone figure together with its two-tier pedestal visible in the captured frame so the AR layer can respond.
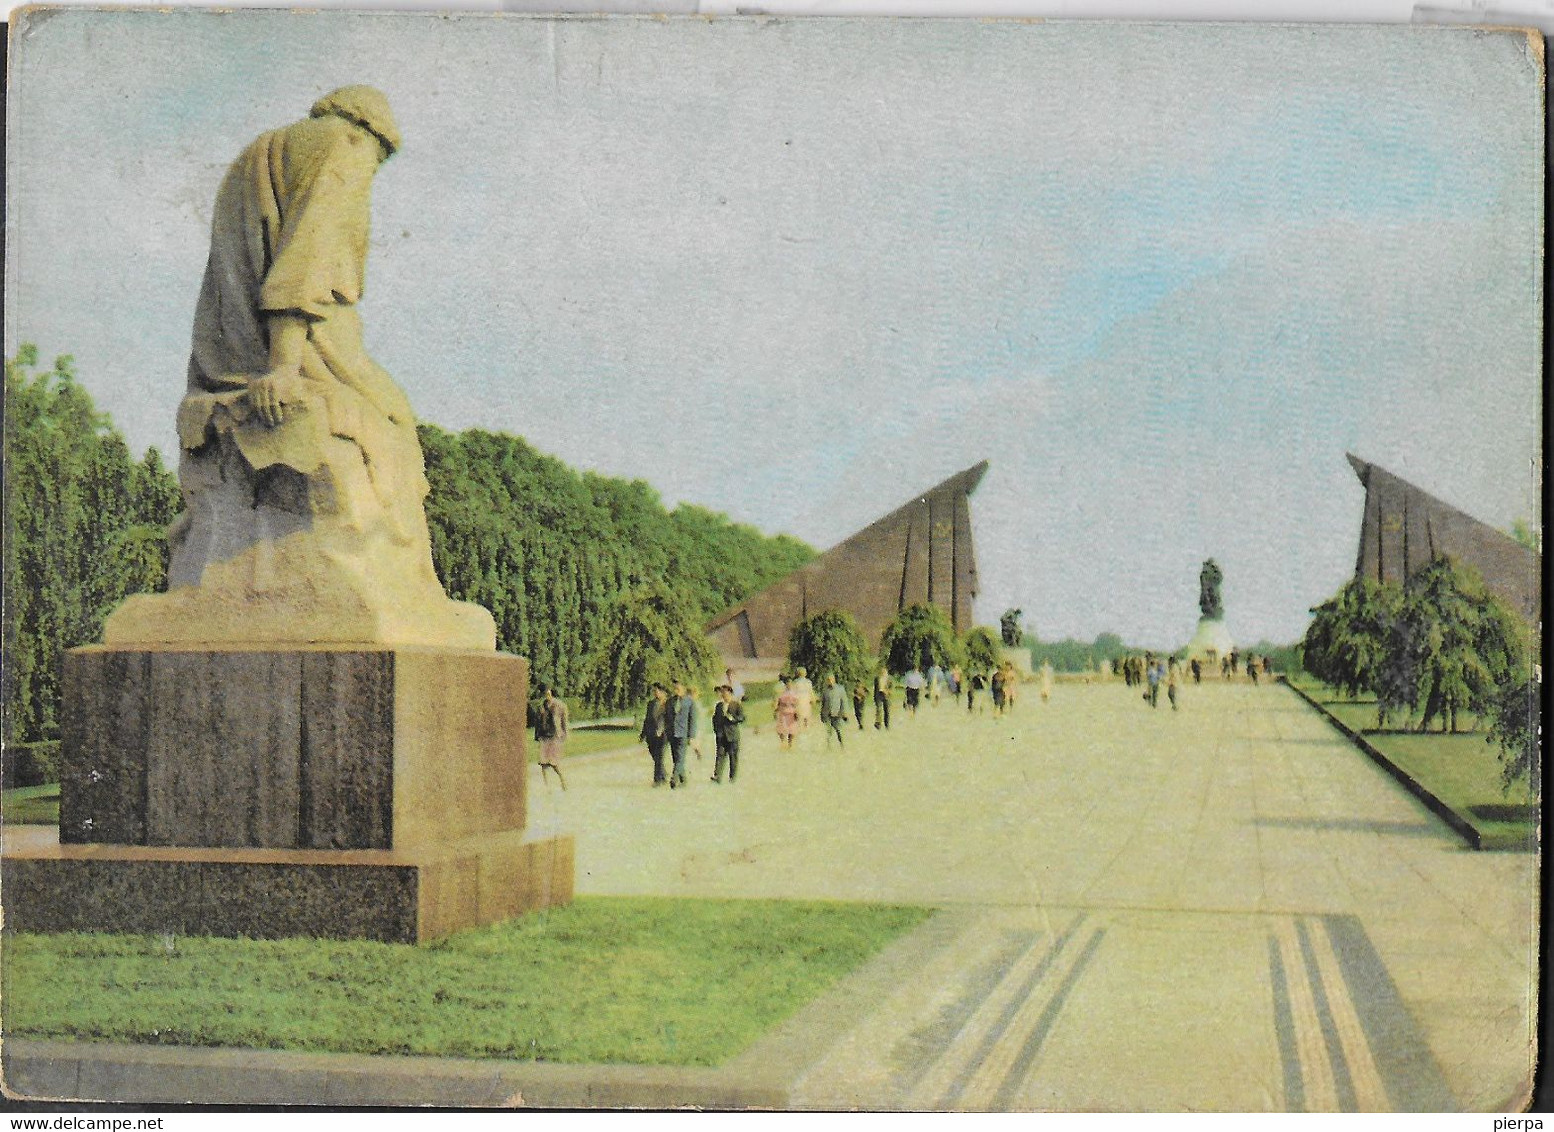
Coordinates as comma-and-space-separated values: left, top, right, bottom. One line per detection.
3, 87, 573, 942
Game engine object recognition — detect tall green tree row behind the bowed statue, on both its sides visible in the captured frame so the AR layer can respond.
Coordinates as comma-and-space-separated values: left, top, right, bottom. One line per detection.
5, 345, 814, 742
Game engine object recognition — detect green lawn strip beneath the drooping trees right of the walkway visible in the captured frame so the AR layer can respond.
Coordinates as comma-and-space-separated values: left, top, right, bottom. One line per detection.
1280, 678, 1537, 849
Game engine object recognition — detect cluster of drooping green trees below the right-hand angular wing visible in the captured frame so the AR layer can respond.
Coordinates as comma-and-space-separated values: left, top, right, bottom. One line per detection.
1302, 558, 1540, 790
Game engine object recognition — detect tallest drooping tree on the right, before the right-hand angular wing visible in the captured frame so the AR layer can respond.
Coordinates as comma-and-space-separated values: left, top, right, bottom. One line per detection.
1389, 558, 1526, 731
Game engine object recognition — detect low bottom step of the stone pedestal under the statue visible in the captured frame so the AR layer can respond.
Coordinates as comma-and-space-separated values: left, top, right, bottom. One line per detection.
0, 829, 573, 944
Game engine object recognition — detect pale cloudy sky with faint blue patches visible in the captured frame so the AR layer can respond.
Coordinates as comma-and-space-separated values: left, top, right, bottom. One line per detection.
6, 11, 1543, 647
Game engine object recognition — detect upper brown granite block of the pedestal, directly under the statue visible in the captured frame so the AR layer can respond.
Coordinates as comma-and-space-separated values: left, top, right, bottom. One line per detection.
59, 645, 528, 849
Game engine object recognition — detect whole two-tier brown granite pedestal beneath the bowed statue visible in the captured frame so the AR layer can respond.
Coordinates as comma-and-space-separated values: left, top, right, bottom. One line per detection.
3, 645, 573, 942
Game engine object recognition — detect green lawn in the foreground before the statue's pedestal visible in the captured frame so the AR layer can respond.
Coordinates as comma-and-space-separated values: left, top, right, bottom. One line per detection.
3, 897, 931, 1065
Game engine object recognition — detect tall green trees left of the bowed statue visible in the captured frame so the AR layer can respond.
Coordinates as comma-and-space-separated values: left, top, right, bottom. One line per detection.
5, 345, 180, 742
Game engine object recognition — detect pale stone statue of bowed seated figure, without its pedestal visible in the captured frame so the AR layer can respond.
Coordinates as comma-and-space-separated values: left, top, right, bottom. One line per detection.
104, 87, 496, 648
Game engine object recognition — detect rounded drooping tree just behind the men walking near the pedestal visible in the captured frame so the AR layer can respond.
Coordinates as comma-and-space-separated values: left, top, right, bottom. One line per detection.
578, 585, 718, 711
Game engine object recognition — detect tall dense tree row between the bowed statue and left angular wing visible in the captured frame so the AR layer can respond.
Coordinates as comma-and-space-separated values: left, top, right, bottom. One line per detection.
421, 425, 814, 706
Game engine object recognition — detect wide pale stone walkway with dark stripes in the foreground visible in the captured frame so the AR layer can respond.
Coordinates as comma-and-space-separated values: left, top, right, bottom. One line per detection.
530, 683, 1537, 1110
